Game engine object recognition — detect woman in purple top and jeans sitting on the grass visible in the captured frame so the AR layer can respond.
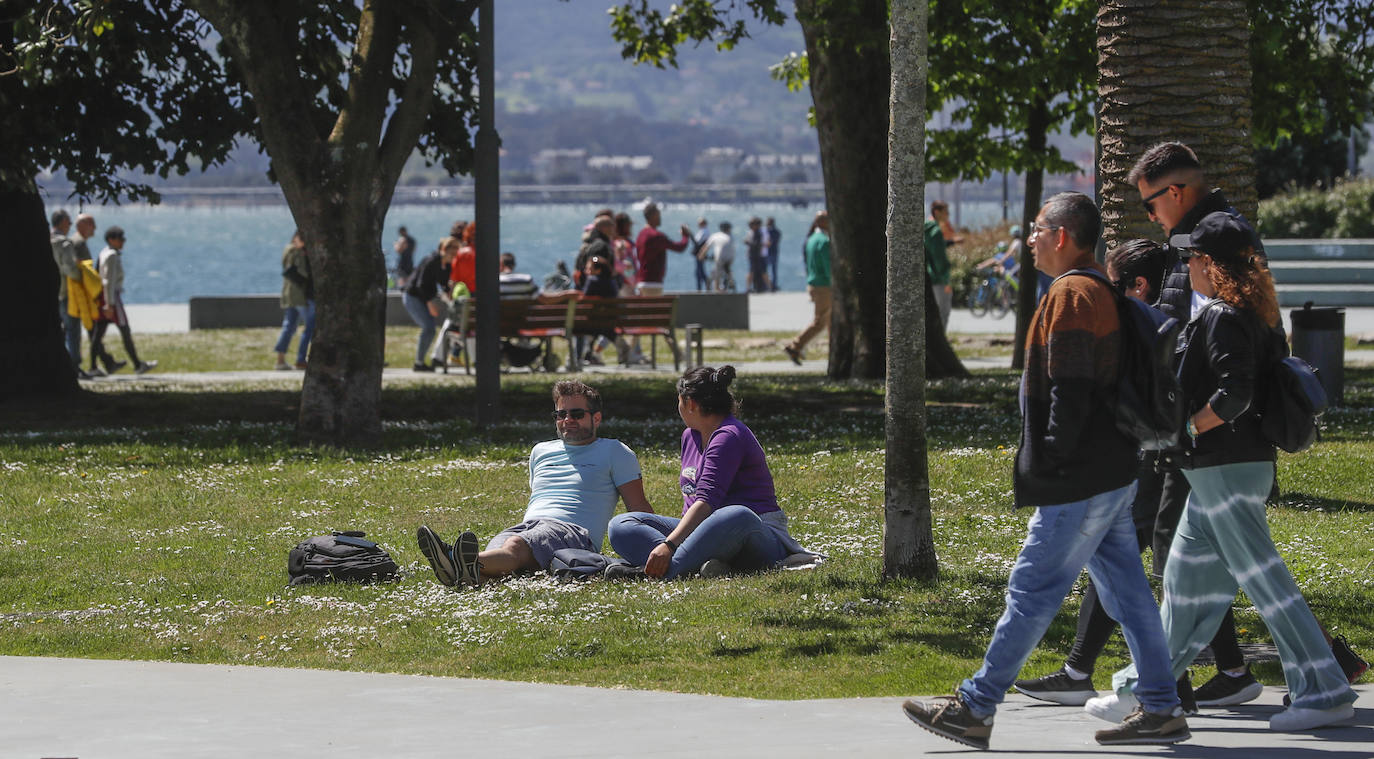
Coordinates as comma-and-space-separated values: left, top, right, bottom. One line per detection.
610, 366, 805, 580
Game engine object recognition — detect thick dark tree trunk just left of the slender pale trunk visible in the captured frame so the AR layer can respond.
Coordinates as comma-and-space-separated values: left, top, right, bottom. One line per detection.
797, 0, 967, 378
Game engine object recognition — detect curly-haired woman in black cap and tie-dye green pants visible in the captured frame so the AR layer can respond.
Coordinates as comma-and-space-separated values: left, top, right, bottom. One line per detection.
1085, 212, 1355, 730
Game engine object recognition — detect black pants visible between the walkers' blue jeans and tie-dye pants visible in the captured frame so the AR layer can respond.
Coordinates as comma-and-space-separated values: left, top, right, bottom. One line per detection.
1066, 455, 1245, 674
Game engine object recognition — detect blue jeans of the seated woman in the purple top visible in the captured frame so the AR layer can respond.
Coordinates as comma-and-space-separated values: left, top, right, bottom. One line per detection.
610, 506, 787, 580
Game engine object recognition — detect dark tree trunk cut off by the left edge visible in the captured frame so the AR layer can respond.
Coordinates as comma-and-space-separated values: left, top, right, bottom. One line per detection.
0, 177, 80, 400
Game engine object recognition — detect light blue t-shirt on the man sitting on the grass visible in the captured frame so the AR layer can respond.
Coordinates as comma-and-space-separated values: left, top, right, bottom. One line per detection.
525, 437, 643, 549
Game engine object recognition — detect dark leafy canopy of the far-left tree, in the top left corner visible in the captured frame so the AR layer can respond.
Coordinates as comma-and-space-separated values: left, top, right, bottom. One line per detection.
0, 1, 250, 201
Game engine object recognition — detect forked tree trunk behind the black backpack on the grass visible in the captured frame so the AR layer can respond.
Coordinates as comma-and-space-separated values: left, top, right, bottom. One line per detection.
192, 0, 437, 446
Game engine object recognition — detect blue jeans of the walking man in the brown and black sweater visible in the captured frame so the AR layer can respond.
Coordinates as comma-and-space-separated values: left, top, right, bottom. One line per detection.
959, 483, 1179, 716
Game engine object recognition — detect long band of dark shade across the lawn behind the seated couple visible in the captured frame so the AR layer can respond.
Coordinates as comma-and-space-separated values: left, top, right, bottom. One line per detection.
0, 375, 1015, 461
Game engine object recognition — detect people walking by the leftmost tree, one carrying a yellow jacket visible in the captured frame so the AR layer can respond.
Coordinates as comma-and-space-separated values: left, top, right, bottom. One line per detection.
48, 209, 158, 380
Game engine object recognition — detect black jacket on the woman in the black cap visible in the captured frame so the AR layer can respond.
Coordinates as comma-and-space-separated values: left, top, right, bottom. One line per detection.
1171, 300, 1282, 468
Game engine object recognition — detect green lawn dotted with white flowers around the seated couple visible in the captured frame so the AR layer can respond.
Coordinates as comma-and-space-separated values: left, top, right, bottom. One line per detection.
0, 365, 1374, 699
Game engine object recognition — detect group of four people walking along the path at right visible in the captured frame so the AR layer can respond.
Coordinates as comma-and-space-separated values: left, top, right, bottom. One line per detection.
903, 143, 1364, 748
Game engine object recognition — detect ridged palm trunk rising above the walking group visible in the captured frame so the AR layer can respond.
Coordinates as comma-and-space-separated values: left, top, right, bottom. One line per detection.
1098, 0, 1259, 246
